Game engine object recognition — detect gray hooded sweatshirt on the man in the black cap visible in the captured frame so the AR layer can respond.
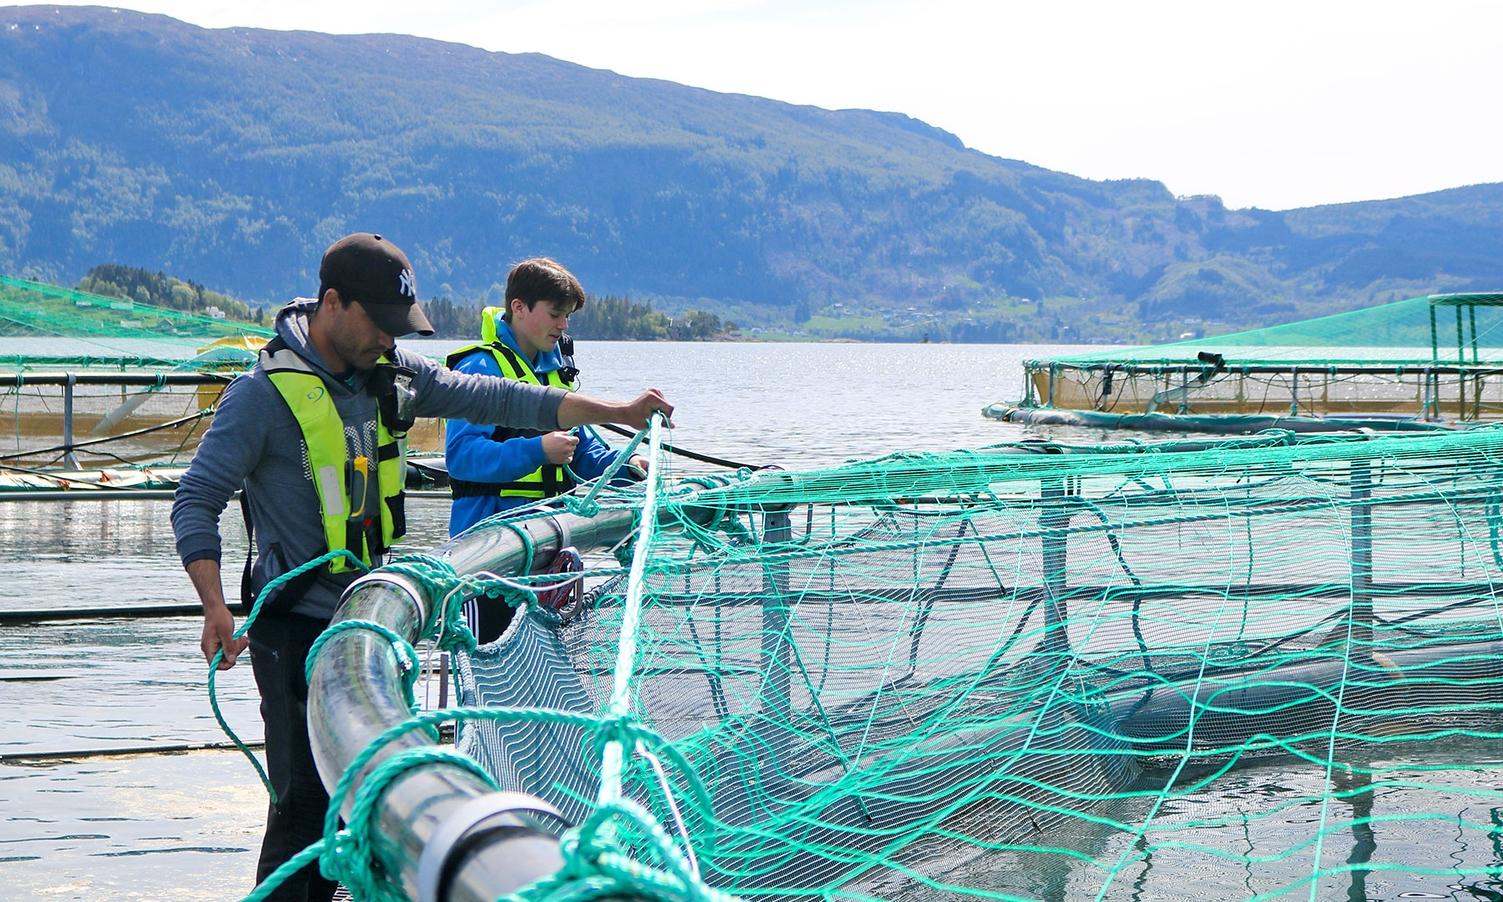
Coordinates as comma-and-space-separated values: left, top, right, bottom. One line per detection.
171, 298, 565, 619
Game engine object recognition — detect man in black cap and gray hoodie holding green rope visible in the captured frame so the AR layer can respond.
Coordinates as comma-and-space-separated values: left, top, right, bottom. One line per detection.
171, 232, 673, 900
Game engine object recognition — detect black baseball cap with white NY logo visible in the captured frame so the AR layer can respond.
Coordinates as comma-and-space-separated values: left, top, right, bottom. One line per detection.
319, 232, 433, 337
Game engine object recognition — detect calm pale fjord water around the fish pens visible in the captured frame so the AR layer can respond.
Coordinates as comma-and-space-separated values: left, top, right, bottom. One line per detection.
0, 341, 1503, 899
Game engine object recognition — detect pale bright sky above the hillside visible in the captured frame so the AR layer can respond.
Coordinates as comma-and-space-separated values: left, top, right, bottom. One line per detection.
23, 0, 1503, 209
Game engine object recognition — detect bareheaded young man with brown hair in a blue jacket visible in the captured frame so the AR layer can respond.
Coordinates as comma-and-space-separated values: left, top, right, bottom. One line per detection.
443, 257, 646, 642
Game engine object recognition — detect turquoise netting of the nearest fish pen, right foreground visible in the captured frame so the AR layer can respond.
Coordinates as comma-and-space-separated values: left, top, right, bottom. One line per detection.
458, 427, 1503, 900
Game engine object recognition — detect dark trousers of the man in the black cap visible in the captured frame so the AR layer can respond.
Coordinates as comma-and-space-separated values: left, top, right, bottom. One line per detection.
251, 613, 334, 902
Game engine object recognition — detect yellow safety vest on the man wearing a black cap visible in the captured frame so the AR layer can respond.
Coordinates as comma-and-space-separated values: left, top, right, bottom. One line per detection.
260, 340, 407, 573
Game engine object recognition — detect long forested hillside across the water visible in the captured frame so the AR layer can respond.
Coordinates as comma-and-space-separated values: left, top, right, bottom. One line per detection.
0, 6, 1503, 340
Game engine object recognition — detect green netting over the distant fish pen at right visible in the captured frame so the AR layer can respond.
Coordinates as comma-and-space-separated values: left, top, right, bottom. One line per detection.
1004, 293, 1503, 428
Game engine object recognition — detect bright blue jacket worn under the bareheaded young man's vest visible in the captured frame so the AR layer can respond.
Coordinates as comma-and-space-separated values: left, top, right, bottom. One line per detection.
443, 320, 616, 535
